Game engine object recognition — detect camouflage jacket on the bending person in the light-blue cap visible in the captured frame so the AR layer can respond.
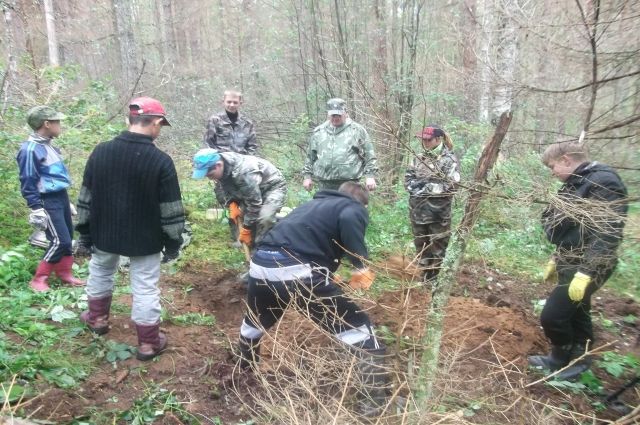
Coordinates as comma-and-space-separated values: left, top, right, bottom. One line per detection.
220, 152, 287, 227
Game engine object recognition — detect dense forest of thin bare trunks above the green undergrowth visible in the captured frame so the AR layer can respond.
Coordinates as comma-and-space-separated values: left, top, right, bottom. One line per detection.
0, 0, 640, 174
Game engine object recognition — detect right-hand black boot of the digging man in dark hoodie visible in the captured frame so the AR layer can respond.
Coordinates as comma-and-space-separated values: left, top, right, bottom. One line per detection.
357, 348, 389, 418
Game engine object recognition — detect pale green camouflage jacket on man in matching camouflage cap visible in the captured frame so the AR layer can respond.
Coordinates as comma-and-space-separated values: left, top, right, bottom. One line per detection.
302, 118, 378, 180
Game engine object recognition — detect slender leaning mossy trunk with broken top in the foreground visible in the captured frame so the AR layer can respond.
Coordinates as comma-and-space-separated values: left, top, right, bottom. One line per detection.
416, 112, 511, 412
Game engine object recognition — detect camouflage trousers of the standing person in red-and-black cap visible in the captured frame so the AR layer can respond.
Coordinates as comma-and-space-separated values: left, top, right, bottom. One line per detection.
411, 220, 451, 282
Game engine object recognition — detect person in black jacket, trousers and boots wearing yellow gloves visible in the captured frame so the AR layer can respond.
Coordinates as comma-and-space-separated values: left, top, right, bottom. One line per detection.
529, 142, 628, 380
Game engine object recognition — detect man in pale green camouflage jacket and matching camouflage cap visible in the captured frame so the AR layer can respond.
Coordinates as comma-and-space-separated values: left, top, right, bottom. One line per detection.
302, 98, 378, 190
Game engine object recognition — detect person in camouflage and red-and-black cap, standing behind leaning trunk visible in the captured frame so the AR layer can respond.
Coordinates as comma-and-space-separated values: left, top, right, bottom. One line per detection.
405, 126, 460, 282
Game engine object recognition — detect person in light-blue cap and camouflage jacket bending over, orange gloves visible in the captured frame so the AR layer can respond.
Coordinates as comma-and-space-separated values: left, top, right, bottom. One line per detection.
193, 148, 287, 247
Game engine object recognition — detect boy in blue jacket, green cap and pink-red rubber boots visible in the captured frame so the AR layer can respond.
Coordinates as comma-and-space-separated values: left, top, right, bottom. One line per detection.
16, 106, 85, 292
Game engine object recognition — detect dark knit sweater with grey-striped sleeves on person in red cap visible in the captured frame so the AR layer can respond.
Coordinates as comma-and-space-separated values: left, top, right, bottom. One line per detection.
76, 131, 184, 257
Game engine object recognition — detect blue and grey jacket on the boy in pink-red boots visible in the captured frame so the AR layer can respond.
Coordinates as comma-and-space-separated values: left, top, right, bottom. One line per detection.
16, 133, 71, 209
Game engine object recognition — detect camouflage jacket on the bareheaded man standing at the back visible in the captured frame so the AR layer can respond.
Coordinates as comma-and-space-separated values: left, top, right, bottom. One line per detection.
204, 111, 258, 155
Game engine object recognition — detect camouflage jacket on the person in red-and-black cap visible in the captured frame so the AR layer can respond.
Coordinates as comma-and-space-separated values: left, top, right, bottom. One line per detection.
404, 145, 460, 197
